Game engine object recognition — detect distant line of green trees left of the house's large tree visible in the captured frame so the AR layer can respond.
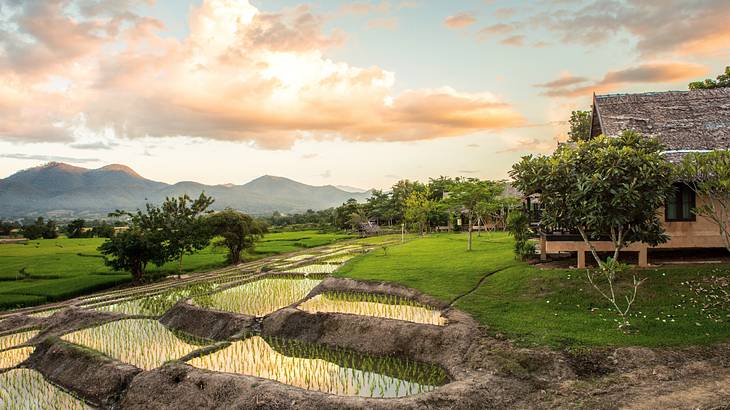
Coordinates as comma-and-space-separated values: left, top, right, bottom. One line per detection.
265, 176, 521, 247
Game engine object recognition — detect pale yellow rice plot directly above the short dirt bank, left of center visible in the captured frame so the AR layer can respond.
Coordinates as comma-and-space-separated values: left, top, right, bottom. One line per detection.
193, 276, 321, 316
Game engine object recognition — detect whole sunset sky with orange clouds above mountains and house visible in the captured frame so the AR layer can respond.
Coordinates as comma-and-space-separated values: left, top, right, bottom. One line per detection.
0, 0, 730, 188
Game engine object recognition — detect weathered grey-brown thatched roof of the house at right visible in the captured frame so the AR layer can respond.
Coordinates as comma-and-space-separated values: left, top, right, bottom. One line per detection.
592, 88, 730, 157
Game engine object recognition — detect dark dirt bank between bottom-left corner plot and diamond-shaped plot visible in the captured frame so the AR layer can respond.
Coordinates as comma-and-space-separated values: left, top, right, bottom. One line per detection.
24, 338, 141, 408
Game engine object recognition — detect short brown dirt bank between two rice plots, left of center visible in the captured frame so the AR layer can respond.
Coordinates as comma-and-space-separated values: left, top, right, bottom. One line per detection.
160, 301, 256, 340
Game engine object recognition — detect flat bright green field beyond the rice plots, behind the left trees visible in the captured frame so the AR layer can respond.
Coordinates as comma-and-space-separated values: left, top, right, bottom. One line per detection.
0, 231, 350, 309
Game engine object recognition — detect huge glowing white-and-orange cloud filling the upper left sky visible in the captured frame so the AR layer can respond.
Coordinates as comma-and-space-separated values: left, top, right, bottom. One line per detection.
0, 0, 524, 149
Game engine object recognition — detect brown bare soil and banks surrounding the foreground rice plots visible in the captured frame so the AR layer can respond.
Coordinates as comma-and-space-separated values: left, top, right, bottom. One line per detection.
3, 278, 730, 409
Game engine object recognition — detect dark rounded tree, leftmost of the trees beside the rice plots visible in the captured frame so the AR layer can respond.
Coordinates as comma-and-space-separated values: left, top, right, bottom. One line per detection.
99, 226, 167, 283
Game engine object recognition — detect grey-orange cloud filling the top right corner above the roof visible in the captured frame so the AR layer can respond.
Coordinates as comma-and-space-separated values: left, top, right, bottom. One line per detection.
532, 0, 730, 56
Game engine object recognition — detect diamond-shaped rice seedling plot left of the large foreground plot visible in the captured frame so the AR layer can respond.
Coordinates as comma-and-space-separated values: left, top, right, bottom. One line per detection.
61, 319, 199, 370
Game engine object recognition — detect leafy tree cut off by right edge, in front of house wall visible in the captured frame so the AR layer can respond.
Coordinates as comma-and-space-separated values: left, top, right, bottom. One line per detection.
678, 151, 730, 252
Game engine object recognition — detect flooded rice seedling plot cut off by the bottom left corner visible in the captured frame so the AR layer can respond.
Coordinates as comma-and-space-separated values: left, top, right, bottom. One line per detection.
0, 369, 90, 410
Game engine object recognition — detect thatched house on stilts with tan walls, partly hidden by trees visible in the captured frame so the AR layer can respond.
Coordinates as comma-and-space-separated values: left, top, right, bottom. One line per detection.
540, 88, 730, 268
